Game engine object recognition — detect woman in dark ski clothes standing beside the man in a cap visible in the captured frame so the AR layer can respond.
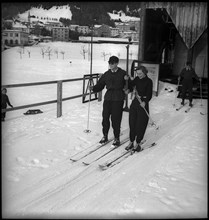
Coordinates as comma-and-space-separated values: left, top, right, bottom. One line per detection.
125, 66, 153, 152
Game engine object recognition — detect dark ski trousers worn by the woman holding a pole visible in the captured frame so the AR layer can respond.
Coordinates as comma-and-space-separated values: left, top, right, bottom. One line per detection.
129, 99, 149, 143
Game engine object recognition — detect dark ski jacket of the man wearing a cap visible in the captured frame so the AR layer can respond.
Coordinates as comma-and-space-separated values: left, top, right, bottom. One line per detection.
93, 67, 126, 101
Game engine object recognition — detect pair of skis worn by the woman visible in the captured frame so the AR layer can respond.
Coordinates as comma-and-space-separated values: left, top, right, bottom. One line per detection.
99, 142, 156, 170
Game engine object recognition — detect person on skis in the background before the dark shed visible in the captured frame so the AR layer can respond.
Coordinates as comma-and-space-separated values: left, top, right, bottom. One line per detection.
178, 61, 201, 107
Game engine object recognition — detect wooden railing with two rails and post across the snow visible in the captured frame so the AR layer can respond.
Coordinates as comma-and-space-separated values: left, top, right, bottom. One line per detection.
1, 74, 101, 117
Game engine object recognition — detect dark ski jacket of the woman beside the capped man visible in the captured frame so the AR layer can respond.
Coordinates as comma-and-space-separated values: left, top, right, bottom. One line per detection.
128, 76, 153, 105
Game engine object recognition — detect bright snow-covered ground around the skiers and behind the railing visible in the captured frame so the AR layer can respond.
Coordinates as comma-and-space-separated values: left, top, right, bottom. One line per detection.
2, 42, 208, 218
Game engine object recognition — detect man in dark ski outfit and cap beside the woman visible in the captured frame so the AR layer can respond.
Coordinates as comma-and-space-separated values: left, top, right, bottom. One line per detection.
92, 56, 126, 146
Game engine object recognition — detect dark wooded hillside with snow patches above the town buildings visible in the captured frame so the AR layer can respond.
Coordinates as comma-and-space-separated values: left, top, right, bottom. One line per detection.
2, 2, 140, 26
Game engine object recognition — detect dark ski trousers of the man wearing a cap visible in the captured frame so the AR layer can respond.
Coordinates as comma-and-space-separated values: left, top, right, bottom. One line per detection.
102, 100, 124, 138
